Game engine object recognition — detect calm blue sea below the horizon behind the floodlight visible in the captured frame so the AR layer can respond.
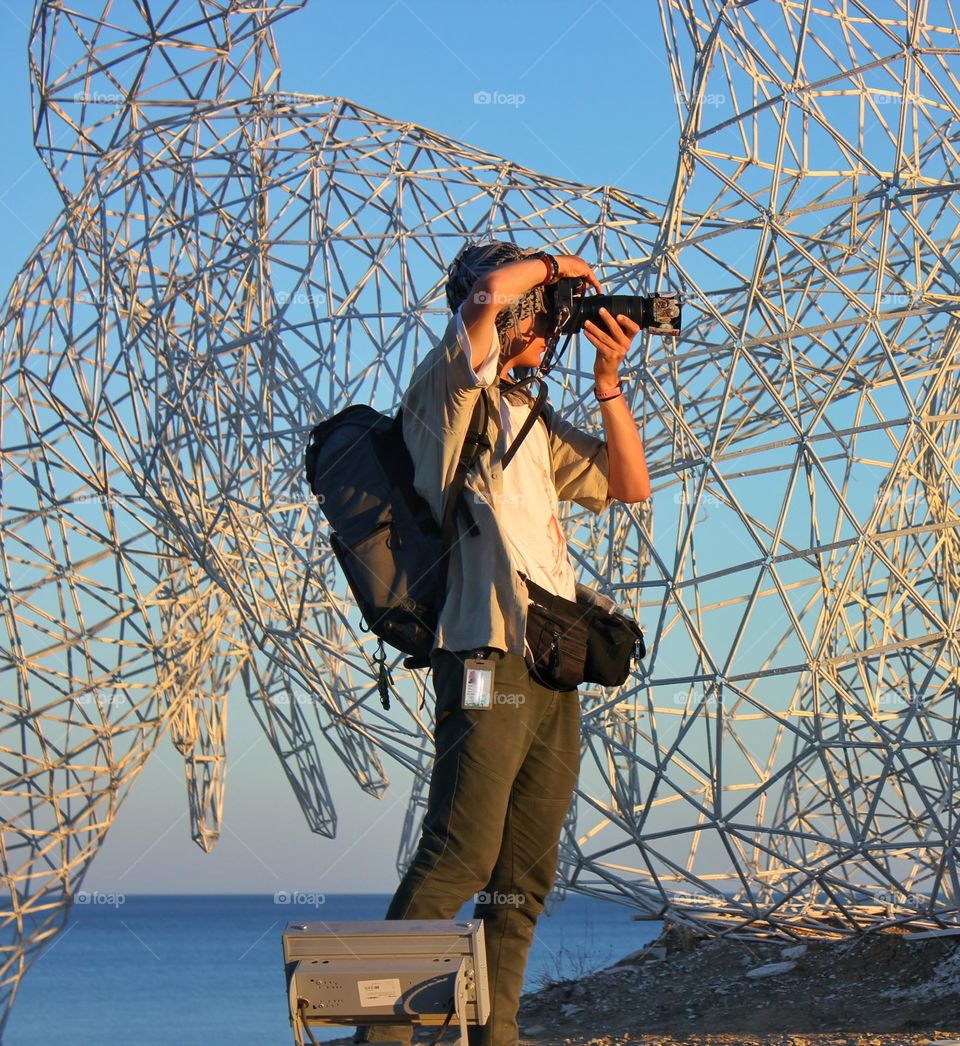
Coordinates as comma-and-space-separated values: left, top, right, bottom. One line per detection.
2, 893, 662, 1046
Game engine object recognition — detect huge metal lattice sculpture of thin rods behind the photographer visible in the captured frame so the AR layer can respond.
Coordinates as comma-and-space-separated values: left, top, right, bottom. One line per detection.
0, 0, 960, 1029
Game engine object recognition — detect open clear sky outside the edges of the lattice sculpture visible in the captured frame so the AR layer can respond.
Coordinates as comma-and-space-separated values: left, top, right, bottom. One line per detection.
0, 0, 677, 894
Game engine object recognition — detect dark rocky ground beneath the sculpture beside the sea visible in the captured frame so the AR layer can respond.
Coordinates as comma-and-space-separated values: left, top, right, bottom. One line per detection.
326, 928, 960, 1046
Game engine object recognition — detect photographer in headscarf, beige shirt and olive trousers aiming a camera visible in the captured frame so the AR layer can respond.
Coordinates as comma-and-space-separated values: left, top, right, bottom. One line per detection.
353, 242, 650, 1046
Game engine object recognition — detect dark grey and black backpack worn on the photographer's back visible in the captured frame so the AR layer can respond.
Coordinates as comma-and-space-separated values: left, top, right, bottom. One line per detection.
303, 384, 547, 708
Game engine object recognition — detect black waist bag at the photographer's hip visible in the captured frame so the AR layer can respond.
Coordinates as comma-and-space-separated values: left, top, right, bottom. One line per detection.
521, 572, 646, 690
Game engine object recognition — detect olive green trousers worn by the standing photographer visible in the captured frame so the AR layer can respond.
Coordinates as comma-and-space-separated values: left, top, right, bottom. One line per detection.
353, 651, 580, 1046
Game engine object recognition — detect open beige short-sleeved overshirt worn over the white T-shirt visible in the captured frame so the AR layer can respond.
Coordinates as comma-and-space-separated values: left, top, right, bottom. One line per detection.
401, 307, 613, 657
